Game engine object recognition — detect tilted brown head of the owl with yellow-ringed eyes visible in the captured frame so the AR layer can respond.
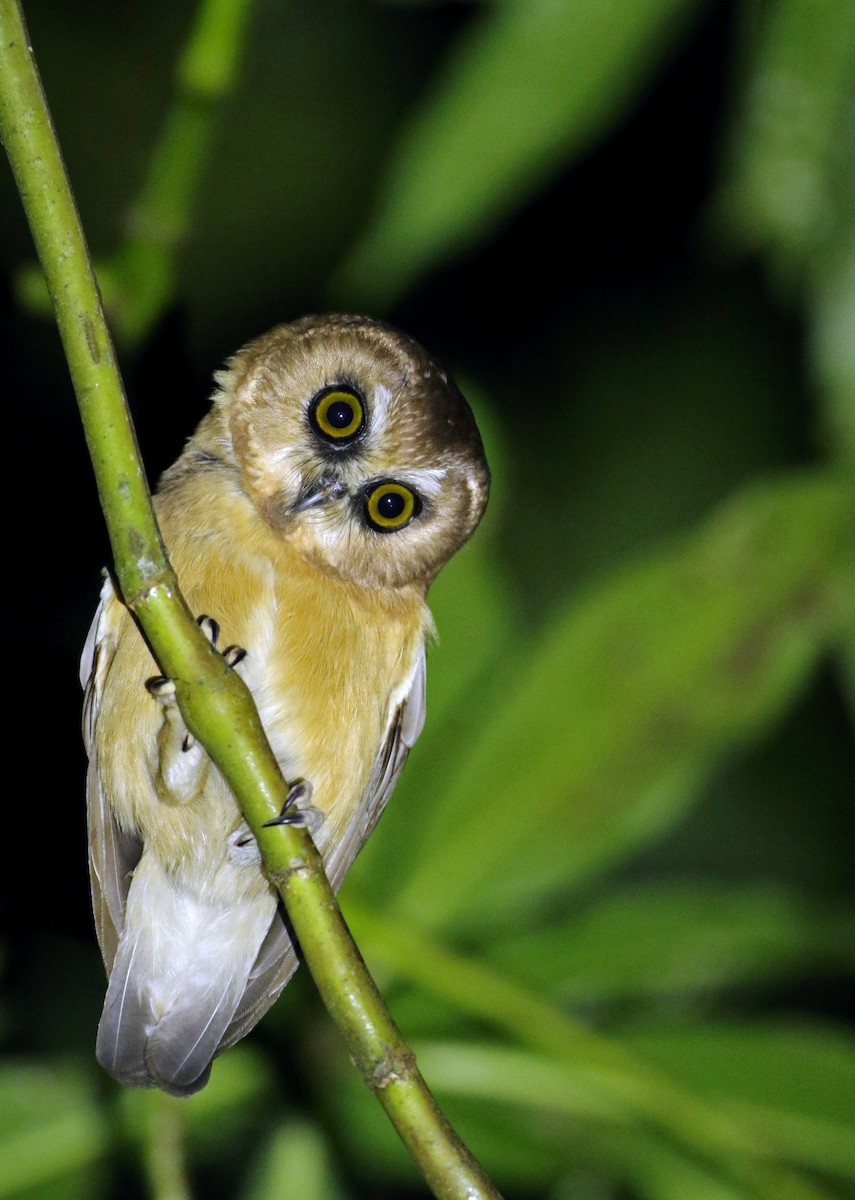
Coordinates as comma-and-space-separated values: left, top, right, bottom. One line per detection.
197, 317, 490, 587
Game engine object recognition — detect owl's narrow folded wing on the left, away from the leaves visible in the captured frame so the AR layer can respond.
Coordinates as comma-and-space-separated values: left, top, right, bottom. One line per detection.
80, 578, 143, 974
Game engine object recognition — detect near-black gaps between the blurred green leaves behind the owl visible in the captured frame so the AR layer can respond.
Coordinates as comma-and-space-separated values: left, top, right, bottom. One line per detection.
0, 0, 855, 1200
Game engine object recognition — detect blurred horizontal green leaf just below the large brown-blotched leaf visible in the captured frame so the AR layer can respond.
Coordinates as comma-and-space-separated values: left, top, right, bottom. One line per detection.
490, 880, 855, 1004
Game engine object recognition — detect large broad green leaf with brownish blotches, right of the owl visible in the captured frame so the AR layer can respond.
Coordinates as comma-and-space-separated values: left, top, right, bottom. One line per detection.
397, 476, 855, 930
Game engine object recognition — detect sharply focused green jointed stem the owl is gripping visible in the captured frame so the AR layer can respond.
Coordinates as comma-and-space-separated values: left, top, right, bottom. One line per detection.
0, 0, 498, 1200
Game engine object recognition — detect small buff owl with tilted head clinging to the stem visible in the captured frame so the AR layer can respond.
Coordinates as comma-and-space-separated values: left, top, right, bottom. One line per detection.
80, 316, 490, 1096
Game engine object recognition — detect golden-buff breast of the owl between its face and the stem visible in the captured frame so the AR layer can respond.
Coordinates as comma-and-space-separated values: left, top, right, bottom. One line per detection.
154, 472, 430, 853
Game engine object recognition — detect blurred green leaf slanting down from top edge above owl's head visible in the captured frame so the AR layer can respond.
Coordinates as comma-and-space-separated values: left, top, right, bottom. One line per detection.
334, 0, 699, 308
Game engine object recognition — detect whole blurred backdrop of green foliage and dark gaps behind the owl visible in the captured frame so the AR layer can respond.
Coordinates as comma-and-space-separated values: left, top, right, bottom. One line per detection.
0, 0, 855, 1200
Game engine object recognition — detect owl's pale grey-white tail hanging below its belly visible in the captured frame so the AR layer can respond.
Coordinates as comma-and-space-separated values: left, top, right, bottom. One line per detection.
96, 856, 275, 1096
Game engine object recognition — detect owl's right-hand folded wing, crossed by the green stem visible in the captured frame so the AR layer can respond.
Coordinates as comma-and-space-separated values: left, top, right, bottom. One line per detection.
217, 649, 425, 1054
